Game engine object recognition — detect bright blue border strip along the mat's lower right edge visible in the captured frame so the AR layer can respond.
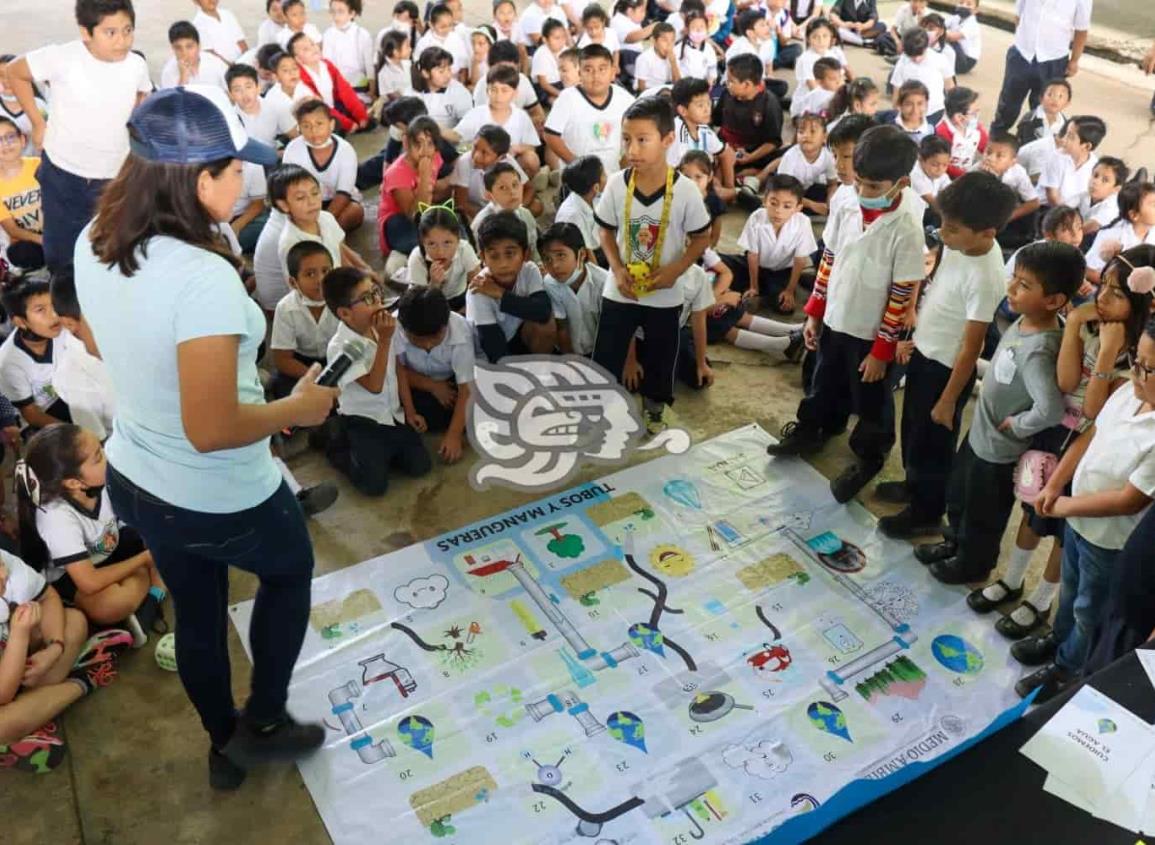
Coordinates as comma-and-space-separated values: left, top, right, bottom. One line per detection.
751, 694, 1035, 845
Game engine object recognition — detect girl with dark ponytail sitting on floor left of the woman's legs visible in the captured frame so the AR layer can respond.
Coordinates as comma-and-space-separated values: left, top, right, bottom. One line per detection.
16, 424, 165, 648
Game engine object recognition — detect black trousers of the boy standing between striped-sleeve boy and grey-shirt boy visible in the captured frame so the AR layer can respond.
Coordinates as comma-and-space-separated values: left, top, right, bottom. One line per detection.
901, 349, 975, 522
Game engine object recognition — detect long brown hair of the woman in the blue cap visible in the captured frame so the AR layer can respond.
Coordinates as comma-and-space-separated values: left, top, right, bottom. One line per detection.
89, 155, 240, 276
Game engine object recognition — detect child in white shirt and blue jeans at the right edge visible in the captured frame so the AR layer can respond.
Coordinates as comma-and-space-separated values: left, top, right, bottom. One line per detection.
1015, 300, 1155, 701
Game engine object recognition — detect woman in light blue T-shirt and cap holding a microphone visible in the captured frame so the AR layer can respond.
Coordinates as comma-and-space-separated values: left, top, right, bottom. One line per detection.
74, 85, 336, 788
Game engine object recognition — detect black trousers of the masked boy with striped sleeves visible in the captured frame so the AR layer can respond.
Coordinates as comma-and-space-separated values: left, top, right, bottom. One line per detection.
798, 326, 895, 466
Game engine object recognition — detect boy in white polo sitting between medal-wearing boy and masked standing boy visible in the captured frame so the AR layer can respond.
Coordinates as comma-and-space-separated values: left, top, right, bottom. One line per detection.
724, 173, 818, 314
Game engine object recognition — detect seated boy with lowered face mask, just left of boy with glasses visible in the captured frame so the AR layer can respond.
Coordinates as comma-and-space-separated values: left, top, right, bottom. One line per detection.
269, 240, 338, 399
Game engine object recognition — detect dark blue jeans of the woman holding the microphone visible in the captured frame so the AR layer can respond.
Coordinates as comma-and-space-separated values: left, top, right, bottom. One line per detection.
107, 465, 313, 748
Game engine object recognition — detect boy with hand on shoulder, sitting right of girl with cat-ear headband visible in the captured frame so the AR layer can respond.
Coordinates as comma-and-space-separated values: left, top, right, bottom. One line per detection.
465, 211, 557, 364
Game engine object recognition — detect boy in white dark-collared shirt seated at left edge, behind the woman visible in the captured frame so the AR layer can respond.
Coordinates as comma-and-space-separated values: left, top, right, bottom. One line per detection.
0, 277, 72, 428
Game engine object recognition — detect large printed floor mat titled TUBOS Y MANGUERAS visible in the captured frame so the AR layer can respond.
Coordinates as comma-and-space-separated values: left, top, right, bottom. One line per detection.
231, 426, 1018, 845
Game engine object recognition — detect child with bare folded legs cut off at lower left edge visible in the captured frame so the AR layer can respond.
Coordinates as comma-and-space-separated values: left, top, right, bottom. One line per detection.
0, 551, 132, 773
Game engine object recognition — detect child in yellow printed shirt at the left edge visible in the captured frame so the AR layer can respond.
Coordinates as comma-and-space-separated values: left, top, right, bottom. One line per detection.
0, 118, 44, 270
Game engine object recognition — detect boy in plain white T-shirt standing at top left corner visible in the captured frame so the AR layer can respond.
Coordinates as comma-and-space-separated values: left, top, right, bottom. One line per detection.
7, 0, 152, 269
